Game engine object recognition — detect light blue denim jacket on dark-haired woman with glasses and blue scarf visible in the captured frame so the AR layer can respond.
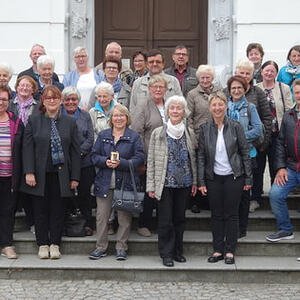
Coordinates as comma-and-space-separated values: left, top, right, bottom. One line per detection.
227, 97, 263, 156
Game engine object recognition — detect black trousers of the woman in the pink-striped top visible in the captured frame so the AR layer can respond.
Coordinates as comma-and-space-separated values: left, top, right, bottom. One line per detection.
0, 177, 17, 247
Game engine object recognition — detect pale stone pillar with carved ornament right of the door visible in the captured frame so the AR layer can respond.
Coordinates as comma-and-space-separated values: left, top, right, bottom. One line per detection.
207, 0, 234, 86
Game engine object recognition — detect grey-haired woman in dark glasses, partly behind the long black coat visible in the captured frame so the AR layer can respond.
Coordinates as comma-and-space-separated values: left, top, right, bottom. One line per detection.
62, 86, 94, 236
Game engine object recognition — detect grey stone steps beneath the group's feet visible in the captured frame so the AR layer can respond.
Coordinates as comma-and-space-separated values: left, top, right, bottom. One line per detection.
0, 196, 300, 283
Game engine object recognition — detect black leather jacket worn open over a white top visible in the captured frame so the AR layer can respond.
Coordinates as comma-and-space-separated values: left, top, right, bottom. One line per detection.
198, 117, 252, 186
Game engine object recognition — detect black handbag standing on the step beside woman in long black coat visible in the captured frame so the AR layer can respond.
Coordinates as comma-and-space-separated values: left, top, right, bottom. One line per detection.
64, 198, 86, 237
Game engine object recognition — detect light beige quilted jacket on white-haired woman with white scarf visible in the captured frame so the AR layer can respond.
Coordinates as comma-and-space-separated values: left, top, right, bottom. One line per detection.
146, 125, 197, 200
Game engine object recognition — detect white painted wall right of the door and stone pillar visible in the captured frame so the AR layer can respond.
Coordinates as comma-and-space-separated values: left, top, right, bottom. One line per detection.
233, 0, 300, 67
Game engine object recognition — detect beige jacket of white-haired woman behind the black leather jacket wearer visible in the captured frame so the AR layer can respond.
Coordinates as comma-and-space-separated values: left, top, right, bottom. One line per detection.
186, 85, 221, 140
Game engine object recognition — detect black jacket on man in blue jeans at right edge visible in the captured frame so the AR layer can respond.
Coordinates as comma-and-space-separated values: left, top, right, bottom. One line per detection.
274, 108, 300, 172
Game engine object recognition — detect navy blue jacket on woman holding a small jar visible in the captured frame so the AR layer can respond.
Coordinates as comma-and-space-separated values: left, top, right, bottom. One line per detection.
91, 127, 145, 198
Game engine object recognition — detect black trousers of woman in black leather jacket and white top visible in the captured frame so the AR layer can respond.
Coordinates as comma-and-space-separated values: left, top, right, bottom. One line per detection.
207, 174, 245, 254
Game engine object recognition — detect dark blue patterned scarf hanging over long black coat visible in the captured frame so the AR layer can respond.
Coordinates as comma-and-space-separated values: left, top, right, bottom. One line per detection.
50, 116, 65, 166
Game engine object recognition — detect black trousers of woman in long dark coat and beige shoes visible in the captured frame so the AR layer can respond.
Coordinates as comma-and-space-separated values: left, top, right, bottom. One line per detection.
32, 172, 68, 246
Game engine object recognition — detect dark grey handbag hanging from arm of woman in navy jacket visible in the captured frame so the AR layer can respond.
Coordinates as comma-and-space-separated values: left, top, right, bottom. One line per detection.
112, 160, 145, 214
